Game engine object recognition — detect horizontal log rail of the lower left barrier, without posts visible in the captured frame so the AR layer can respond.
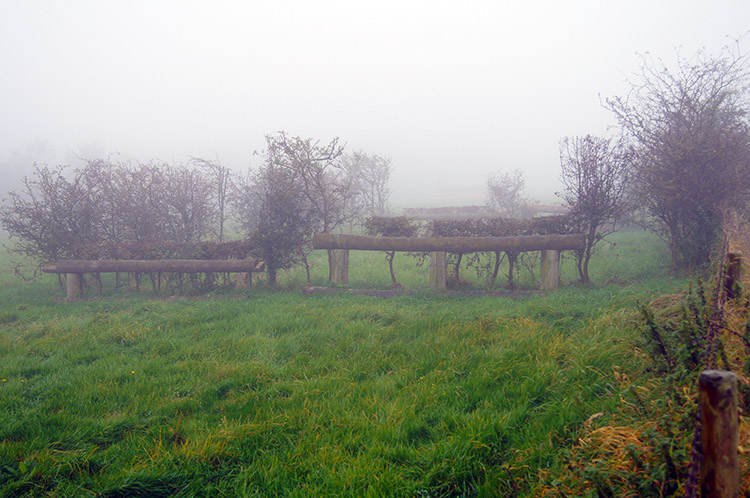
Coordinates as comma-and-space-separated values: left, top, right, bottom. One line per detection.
42, 259, 264, 273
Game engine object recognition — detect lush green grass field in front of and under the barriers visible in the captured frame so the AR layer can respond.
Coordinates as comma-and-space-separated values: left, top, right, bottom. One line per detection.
0, 232, 685, 497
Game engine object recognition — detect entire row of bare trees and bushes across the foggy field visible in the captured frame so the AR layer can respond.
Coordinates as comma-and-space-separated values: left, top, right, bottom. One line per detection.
0, 46, 750, 285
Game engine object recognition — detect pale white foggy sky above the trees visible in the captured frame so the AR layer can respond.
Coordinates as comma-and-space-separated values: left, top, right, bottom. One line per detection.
0, 0, 750, 207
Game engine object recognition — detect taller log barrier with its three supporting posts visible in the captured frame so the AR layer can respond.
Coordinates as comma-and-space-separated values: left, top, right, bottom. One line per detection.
313, 233, 586, 290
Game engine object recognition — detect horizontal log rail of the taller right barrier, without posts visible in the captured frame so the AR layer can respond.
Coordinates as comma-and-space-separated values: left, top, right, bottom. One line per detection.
313, 233, 585, 253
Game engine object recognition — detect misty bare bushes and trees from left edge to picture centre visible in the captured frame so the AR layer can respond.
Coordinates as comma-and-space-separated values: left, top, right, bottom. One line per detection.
0, 132, 391, 284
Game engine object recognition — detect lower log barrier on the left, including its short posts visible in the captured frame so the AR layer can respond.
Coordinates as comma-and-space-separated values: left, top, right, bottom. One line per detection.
42, 259, 265, 299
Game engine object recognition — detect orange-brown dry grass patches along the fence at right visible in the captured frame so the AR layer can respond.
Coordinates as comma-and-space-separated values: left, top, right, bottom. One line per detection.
537, 215, 750, 497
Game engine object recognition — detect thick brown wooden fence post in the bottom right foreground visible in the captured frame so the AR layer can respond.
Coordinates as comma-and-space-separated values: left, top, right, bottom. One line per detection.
698, 370, 740, 498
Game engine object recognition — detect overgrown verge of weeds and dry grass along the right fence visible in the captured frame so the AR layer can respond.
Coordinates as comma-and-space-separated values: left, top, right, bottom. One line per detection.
537, 212, 750, 498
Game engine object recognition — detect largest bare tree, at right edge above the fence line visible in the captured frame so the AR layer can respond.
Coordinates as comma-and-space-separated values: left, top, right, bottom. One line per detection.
606, 49, 750, 269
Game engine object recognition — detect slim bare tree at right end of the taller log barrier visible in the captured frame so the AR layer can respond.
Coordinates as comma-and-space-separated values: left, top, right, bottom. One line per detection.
558, 135, 630, 283
